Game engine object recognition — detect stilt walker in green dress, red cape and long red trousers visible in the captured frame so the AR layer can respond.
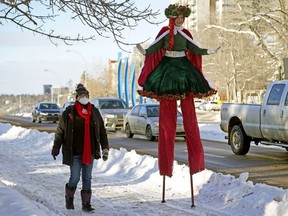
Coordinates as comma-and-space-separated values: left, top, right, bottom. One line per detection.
136, 4, 220, 207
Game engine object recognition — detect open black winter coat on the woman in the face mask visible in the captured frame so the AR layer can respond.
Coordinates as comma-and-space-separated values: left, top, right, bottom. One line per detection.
53, 105, 109, 165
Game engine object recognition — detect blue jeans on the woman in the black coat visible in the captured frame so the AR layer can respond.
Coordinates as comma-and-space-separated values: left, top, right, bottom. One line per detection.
68, 155, 94, 190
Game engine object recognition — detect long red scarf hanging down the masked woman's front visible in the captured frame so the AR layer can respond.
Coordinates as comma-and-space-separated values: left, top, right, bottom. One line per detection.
75, 101, 92, 164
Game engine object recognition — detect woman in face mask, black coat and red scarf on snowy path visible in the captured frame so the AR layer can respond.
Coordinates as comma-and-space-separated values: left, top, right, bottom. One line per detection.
51, 84, 109, 211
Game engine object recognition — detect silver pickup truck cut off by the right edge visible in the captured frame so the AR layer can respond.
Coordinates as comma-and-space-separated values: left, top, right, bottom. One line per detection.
220, 80, 288, 155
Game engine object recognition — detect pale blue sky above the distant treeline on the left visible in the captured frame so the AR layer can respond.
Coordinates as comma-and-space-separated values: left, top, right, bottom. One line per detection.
0, 0, 170, 95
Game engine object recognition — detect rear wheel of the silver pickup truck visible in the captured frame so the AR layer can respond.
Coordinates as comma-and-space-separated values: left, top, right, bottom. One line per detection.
229, 125, 250, 155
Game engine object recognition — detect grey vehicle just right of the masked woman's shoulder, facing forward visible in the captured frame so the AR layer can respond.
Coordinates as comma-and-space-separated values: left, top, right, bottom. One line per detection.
91, 98, 130, 131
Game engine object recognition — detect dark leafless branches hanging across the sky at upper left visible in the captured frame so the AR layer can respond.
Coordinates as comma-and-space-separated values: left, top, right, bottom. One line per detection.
0, 0, 159, 48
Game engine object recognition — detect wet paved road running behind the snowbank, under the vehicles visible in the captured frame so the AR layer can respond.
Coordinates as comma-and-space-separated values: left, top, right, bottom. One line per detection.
0, 113, 288, 189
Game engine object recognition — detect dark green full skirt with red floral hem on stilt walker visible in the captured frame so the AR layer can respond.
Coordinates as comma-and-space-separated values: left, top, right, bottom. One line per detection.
138, 56, 217, 100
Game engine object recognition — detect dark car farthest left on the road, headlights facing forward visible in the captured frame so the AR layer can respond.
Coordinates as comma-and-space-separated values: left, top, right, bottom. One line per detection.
32, 102, 60, 123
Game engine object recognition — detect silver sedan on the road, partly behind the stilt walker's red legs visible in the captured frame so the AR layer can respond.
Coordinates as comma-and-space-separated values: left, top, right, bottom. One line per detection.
124, 104, 185, 141
